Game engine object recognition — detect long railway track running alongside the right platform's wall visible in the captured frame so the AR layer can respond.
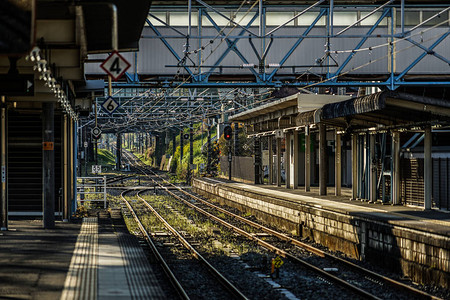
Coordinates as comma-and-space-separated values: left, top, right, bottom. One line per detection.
118, 149, 440, 299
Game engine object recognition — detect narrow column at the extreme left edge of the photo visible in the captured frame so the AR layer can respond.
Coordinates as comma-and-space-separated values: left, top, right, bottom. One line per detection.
0, 96, 8, 230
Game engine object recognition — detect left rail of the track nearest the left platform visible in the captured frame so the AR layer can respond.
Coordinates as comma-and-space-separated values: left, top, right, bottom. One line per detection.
120, 190, 190, 300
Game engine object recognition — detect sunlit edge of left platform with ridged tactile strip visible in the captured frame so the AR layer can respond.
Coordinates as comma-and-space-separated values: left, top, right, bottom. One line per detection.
61, 218, 165, 300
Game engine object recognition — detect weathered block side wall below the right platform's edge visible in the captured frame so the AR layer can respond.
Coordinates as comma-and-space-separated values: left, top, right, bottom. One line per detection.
192, 179, 450, 288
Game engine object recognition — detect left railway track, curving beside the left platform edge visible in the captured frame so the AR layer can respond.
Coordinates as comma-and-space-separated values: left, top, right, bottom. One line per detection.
121, 191, 248, 299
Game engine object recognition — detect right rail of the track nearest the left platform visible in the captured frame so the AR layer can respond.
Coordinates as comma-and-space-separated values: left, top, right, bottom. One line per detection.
130, 191, 248, 300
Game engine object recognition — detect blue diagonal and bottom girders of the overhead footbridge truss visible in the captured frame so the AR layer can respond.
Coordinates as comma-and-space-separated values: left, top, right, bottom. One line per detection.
117, 1, 450, 90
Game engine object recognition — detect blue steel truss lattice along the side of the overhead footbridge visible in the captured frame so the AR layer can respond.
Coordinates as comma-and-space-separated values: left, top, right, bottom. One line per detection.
134, 0, 450, 89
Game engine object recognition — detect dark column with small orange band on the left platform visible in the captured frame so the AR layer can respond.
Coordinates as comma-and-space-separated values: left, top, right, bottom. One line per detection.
42, 102, 55, 228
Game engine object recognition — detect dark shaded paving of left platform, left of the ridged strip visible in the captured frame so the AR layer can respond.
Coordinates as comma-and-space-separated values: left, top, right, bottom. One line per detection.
0, 220, 80, 299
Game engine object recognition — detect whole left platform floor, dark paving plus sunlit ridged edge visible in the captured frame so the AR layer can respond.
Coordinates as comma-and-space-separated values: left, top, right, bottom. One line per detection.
0, 212, 166, 299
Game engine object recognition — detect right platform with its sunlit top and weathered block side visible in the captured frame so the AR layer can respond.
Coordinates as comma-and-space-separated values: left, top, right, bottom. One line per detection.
192, 177, 450, 289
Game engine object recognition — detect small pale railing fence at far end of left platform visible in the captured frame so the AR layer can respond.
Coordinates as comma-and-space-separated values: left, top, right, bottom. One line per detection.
77, 176, 106, 208
